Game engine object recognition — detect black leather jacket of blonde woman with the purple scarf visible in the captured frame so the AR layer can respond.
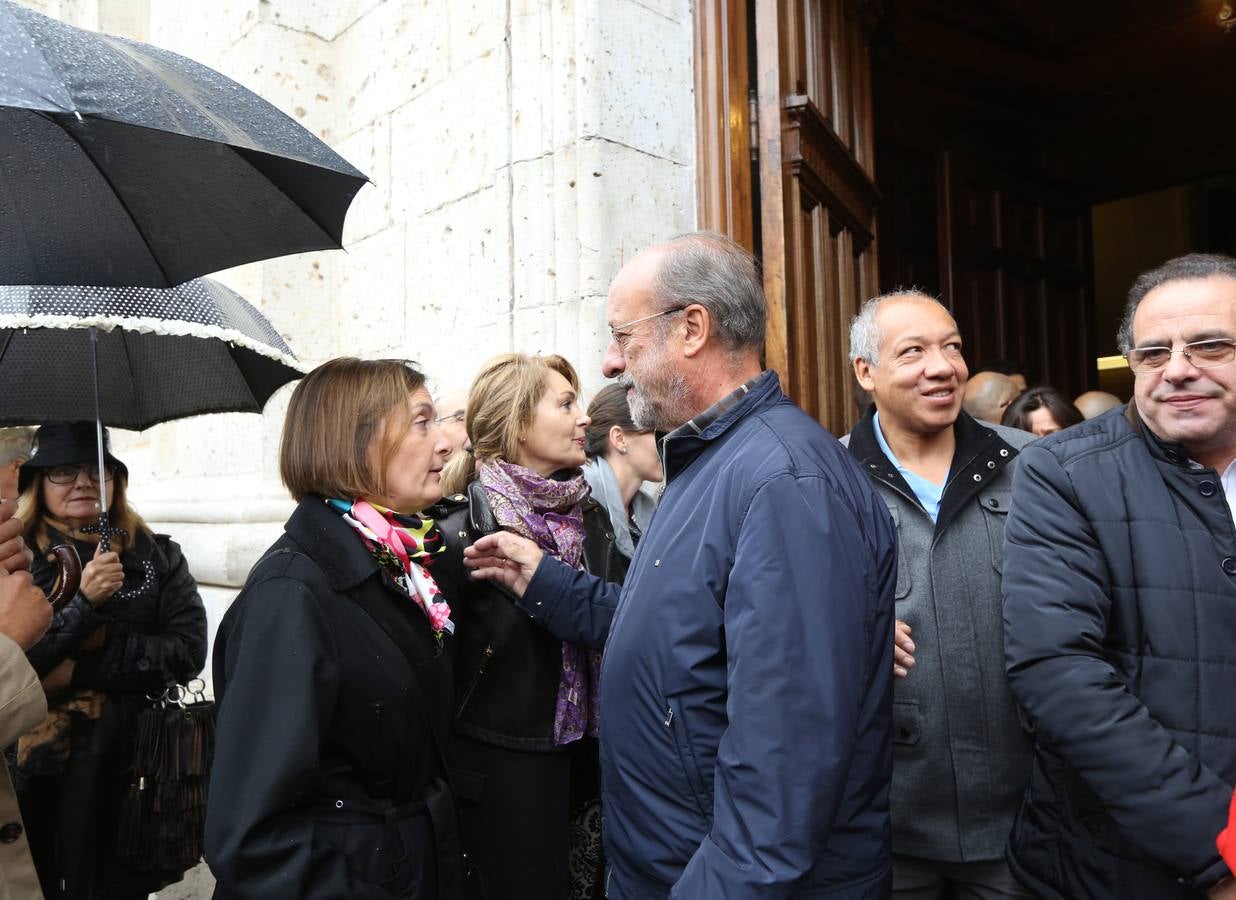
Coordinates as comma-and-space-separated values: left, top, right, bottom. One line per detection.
429, 481, 629, 752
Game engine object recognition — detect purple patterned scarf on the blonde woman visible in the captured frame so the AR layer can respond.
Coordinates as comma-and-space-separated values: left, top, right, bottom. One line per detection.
480, 460, 601, 744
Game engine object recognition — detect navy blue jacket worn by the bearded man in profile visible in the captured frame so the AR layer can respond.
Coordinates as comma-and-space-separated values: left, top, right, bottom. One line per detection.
522, 372, 896, 900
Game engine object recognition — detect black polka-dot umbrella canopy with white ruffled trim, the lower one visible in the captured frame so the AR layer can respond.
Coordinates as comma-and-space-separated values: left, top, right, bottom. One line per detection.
0, 278, 303, 430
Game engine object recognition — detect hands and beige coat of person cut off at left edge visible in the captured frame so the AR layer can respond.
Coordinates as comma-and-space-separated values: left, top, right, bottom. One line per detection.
0, 503, 52, 900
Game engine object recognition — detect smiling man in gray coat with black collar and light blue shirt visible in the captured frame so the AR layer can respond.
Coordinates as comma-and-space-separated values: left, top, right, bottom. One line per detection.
847, 292, 1033, 900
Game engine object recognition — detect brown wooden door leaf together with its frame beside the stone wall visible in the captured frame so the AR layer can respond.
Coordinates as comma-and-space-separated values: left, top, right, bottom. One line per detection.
695, 0, 879, 434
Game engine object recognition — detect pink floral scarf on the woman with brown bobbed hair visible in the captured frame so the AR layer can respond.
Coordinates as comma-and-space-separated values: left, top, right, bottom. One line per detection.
326, 498, 455, 645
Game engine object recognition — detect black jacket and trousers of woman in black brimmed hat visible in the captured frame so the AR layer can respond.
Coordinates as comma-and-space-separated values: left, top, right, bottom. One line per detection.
15, 532, 206, 900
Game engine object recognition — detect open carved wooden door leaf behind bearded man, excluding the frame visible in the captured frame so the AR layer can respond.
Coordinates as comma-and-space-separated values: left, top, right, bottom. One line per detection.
754, 0, 879, 434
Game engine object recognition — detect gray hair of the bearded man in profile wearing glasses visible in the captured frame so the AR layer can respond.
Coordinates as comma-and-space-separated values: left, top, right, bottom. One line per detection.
653, 231, 768, 352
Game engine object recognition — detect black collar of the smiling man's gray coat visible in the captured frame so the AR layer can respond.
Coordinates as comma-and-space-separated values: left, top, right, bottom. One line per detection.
849, 408, 1017, 534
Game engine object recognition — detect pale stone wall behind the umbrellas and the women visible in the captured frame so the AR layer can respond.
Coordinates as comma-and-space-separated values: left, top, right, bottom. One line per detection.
19, 0, 695, 898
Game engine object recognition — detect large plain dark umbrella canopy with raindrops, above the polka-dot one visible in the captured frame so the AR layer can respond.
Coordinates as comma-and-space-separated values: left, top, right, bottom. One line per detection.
0, 0, 367, 287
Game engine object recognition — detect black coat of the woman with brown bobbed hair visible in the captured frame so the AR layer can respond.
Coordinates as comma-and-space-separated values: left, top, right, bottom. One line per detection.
206, 496, 460, 900
